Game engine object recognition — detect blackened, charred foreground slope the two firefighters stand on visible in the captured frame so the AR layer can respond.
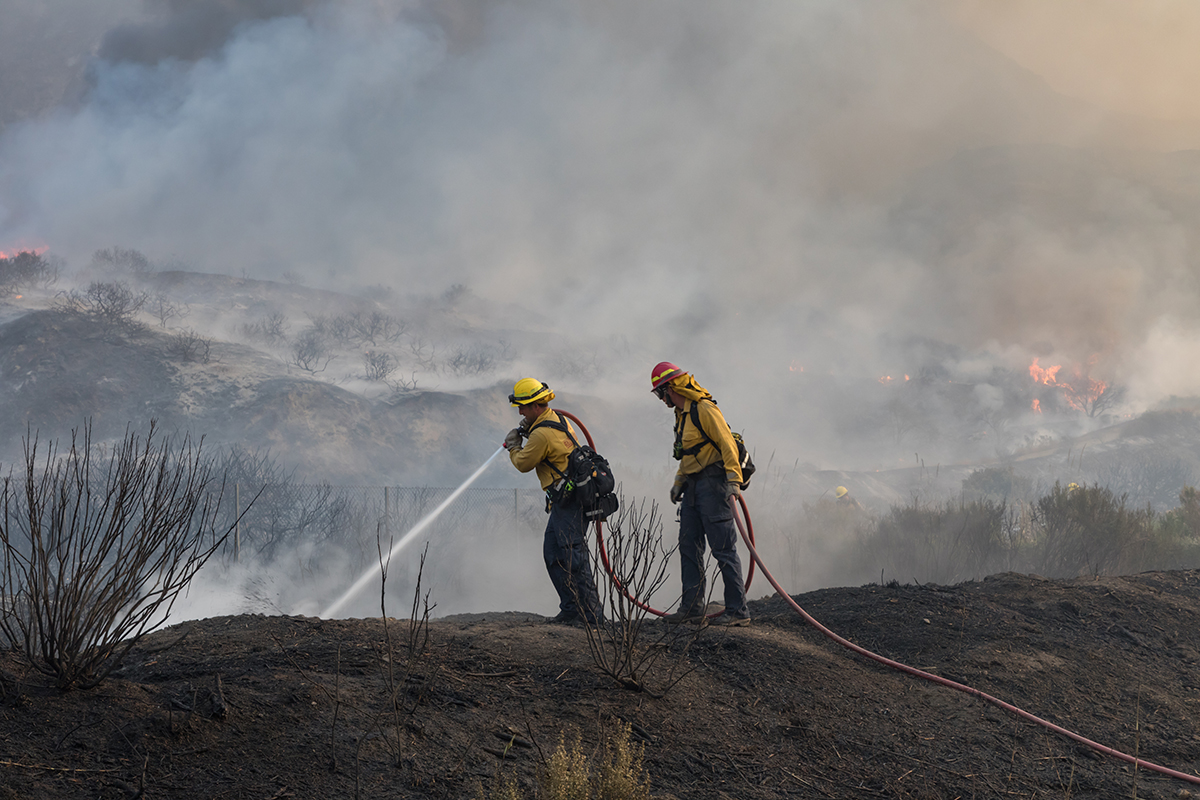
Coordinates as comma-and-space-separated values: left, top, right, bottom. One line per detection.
0, 571, 1200, 800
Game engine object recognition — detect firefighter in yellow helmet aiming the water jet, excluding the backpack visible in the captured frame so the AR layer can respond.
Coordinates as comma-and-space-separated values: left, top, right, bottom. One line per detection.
504, 378, 604, 625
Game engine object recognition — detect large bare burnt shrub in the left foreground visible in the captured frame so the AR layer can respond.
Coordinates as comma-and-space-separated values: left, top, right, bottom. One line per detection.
0, 422, 241, 690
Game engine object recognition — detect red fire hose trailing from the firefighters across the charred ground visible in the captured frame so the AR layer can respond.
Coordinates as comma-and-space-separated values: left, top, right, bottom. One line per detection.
559, 411, 1200, 786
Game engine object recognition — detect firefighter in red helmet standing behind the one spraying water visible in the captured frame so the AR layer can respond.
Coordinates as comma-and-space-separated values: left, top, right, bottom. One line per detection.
650, 361, 750, 625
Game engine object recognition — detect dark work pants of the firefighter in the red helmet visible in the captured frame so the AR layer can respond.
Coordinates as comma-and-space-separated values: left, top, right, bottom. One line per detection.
679, 469, 750, 616
